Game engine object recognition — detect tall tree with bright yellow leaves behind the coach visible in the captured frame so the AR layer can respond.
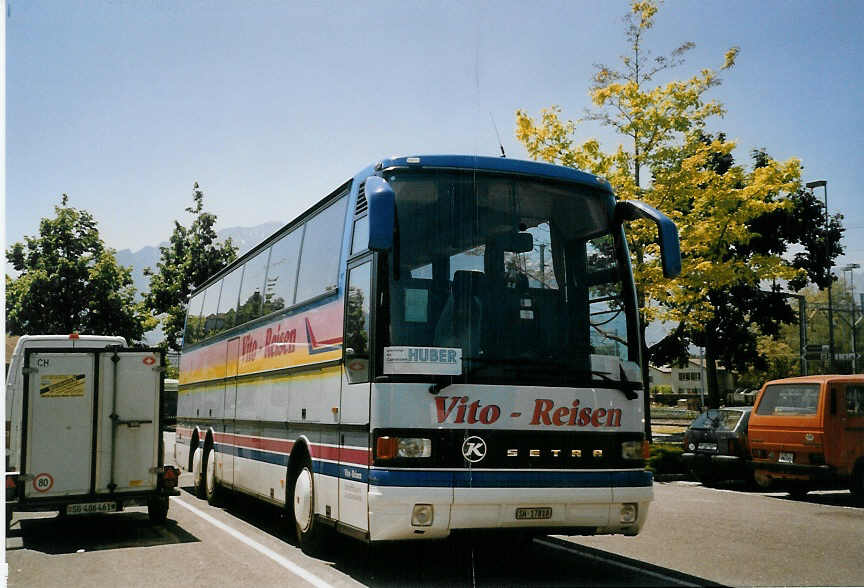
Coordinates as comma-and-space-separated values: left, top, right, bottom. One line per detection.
516, 1, 802, 412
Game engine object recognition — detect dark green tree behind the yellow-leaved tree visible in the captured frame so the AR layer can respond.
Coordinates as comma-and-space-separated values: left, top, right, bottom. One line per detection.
650, 142, 843, 405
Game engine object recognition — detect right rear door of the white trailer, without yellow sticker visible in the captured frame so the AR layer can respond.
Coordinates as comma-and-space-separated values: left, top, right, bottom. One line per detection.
96, 350, 161, 494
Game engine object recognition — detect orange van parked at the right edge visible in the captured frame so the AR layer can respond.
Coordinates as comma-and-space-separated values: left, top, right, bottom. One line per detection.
748, 375, 864, 498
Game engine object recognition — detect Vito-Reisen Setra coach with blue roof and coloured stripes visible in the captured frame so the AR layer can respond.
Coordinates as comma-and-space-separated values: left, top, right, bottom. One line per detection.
177, 155, 680, 548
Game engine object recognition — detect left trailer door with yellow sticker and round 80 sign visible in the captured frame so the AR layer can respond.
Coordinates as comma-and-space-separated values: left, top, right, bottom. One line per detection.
22, 352, 96, 498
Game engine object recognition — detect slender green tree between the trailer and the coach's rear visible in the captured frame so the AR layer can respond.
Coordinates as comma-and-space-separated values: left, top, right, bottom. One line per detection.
144, 182, 237, 351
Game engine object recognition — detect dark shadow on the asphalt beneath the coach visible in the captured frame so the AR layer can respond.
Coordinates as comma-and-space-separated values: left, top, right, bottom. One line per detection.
184, 488, 716, 588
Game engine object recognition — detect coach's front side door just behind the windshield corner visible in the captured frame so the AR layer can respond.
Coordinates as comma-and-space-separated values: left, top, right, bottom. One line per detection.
339, 257, 372, 531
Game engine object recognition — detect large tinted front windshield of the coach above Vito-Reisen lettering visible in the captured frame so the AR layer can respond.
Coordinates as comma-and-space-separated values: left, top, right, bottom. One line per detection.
379, 171, 639, 388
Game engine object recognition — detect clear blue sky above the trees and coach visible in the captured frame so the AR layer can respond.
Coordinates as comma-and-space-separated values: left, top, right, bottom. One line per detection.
6, 0, 864, 276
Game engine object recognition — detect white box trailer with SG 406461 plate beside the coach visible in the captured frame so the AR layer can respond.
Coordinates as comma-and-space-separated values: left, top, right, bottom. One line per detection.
6, 335, 179, 525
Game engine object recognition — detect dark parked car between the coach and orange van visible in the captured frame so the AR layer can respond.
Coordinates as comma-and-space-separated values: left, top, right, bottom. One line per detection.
681, 406, 752, 484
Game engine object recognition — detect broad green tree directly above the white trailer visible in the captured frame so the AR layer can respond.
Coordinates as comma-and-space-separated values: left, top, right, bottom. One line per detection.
6, 194, 155, 343
